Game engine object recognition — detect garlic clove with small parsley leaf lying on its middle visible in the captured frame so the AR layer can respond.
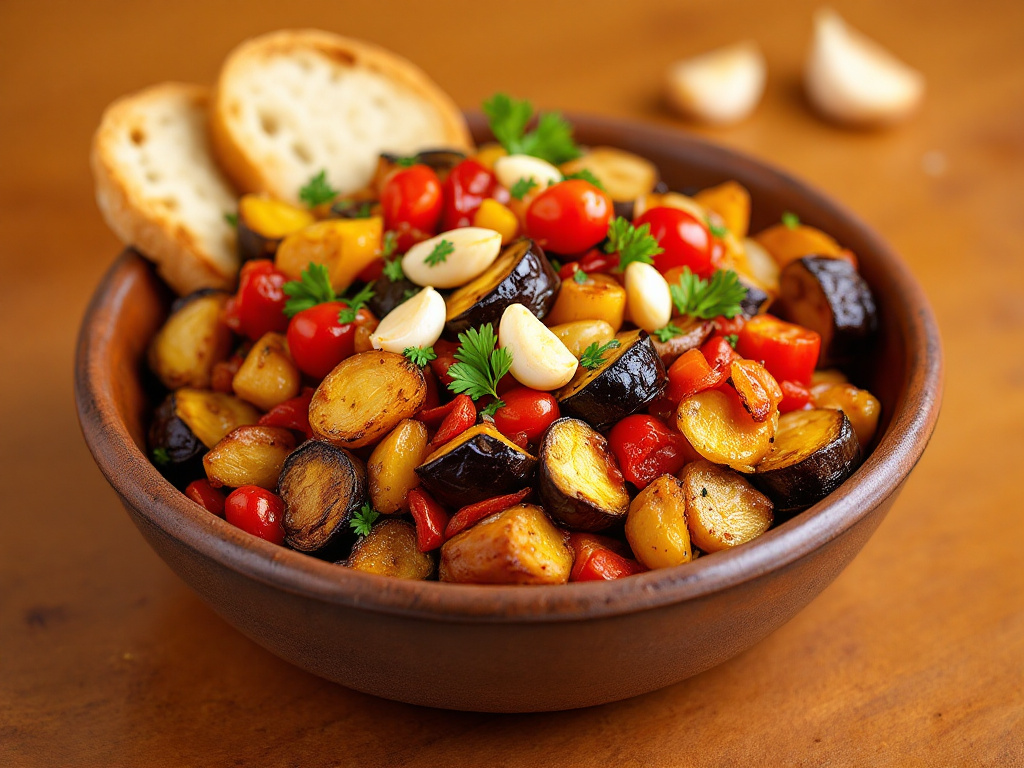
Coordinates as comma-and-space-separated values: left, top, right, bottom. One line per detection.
401, 226, 502, 288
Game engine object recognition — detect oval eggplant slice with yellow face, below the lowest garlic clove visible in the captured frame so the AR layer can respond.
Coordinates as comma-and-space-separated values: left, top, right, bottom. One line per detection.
540, 418, 630, 530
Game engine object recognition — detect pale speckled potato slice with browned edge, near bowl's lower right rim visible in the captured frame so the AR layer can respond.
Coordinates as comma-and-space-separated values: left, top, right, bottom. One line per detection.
679, 459, 773, 552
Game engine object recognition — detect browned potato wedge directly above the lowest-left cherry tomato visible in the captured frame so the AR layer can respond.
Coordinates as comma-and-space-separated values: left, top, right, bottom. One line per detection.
203, 424, 295, 490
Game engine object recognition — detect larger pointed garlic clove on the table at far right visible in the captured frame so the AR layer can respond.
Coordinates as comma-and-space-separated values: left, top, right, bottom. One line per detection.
804, 8, 925, 126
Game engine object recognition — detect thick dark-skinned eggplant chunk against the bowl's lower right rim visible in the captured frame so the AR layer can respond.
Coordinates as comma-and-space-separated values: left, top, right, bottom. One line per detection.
751, 409, 860, 515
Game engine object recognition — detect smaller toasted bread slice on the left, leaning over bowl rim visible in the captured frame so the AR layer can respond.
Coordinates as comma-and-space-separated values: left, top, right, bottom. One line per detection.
92, 83, 239, 294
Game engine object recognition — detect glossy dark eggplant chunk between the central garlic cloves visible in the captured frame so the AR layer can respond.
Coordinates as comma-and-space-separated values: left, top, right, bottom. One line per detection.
444, 240, 561, 334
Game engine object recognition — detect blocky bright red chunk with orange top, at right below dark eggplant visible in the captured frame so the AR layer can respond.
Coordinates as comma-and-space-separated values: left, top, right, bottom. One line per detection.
736, 314, 821, 387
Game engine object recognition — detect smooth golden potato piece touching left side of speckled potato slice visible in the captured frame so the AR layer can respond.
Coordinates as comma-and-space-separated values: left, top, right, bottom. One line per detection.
626, 475, 693, 568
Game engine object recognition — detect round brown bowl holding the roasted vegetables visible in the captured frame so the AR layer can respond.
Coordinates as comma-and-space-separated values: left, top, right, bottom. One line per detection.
76, 116, 942, 712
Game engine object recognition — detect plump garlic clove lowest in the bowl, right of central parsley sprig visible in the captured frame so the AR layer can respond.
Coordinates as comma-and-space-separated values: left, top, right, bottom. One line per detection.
498, 304, 579, 392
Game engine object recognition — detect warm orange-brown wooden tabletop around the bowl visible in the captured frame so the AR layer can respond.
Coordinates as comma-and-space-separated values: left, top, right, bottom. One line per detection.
0, 0, 1024, 767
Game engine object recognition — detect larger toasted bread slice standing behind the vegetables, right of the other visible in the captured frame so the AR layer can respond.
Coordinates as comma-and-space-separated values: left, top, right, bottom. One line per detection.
211, 30, 472, 203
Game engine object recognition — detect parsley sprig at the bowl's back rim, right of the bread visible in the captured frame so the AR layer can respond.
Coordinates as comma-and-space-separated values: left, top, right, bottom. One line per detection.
483, 93, 581, 165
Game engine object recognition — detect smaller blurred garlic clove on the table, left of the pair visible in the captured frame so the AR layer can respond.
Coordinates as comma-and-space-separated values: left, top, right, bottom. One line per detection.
668, 41, 767, 125
